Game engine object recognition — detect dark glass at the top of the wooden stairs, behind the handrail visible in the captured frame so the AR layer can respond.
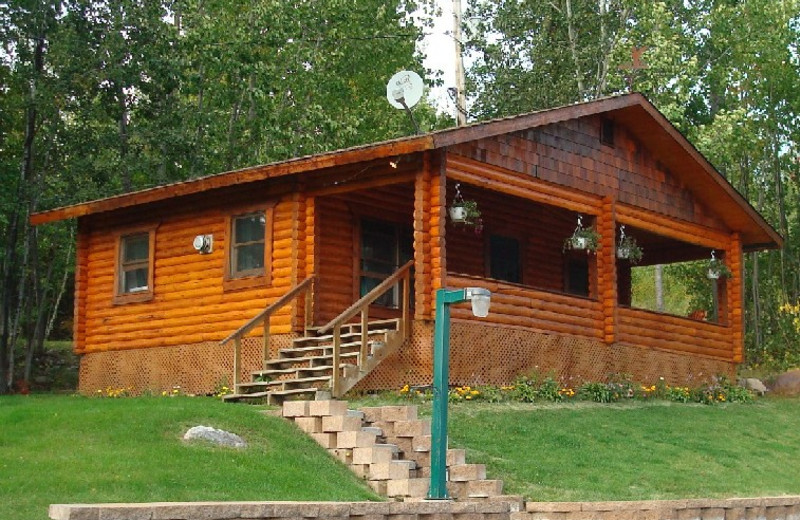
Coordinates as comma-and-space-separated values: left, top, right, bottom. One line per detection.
359, 219, 414, 307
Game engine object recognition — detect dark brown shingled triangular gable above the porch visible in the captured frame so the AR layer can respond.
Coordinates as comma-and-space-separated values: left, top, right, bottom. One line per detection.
450, 116, 723, 229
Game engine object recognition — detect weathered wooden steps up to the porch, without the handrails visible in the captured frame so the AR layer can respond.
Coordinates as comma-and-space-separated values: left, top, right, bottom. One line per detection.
224, 319, 405, 404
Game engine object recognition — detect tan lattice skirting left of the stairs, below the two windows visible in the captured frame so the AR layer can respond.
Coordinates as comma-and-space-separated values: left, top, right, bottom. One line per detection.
78, 334, 297, 395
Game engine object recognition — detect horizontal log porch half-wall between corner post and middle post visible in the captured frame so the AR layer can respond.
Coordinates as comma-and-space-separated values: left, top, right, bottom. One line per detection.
447, 274, 603, 339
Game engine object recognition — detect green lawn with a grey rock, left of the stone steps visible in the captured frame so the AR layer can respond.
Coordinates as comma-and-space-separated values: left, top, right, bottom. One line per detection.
0, 395, 378, 520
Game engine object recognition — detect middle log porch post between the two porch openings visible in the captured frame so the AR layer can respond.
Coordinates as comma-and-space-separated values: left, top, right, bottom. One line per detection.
597, 197, 619, 345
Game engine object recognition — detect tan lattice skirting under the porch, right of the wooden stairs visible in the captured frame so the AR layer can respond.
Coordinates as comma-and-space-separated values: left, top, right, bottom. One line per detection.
355, 321, 736, 390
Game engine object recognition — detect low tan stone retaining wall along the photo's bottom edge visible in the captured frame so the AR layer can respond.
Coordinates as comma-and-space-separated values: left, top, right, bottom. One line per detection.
50, 496, 800, 520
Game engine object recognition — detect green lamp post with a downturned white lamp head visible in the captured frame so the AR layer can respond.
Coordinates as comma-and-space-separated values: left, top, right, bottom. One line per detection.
428, 287, 492, 500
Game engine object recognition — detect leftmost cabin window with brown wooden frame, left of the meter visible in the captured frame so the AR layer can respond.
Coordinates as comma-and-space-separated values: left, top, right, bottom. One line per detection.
114, 229, 155, 303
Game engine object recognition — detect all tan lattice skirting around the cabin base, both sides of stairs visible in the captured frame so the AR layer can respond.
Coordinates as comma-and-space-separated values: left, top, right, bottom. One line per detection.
79, 321, 736, 394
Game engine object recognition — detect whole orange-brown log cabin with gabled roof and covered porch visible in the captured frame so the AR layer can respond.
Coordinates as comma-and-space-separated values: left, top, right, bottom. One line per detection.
31, 93, 782, 402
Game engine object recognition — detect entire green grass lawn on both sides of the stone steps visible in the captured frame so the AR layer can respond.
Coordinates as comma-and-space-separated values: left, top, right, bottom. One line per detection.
0, 396, 800, 520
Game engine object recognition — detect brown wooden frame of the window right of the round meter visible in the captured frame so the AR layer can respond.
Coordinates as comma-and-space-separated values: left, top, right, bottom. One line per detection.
222, 203, 275, 291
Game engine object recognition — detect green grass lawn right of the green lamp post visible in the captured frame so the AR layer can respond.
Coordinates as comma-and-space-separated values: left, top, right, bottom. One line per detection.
449, 399, 800, 501
